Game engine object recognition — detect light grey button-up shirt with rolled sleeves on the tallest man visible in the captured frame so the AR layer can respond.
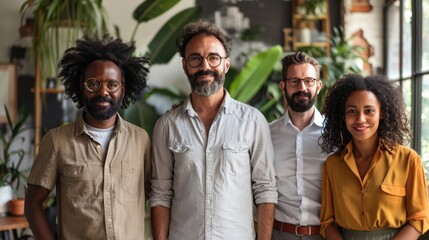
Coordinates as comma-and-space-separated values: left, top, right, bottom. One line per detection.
150, 91, 277, 240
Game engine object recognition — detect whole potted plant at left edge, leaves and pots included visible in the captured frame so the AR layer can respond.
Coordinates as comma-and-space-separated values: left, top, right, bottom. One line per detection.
0, 107, 29, 215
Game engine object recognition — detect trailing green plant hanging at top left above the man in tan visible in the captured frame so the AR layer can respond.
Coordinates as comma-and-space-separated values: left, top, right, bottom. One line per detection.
20, 0, 107, 82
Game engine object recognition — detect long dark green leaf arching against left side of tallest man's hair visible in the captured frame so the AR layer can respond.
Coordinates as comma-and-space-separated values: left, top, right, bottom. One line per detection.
148, 7, 201, 64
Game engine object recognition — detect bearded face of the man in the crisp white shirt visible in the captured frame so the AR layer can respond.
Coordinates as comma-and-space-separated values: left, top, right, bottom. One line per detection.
279, 63, 322, 112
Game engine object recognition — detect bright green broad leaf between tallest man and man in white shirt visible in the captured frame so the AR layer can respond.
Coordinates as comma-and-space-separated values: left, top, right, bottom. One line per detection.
228, 45, 283, 102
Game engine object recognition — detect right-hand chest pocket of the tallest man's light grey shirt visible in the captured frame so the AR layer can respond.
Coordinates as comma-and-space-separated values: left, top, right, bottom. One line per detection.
222, 143, 251, 176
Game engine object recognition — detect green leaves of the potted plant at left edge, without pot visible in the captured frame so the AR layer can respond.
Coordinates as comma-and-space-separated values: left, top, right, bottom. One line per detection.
0, 106, 29, 195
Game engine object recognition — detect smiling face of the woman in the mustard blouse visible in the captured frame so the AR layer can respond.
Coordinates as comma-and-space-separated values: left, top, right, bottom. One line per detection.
345, 90, 381, 141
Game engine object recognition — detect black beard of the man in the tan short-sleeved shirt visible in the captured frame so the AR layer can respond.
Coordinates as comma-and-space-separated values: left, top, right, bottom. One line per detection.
83, 96, 122, 120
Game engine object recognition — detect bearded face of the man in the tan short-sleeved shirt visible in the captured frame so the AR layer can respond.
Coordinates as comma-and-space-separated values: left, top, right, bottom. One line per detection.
82, 60, 125, 127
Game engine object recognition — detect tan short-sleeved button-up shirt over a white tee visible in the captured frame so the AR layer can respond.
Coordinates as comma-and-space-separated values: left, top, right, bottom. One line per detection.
28, 115, 151, 240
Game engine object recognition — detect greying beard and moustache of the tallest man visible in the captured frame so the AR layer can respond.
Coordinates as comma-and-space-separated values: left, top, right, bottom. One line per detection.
186, 71, 225, 97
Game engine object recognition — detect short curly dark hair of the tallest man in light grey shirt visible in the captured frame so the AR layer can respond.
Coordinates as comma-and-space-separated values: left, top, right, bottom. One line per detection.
176, 19, 231, 58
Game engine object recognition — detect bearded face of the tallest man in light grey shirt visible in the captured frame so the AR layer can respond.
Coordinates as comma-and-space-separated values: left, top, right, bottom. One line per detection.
182, 35, 230, 96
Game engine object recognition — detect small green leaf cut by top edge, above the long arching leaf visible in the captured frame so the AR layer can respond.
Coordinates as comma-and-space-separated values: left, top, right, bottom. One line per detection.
133, 0, 180, 23
